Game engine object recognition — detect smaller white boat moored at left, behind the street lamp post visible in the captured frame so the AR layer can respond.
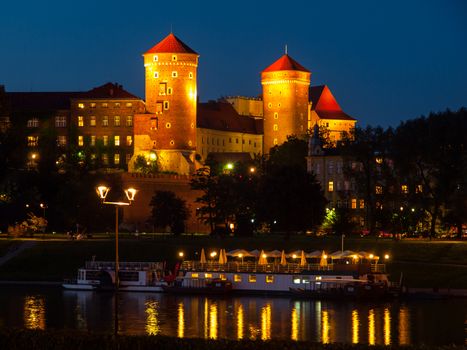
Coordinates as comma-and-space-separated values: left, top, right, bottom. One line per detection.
62, 261, 167, 292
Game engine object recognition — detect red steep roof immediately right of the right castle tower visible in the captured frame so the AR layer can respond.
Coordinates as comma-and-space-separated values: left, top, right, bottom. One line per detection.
310, 85, 355, 120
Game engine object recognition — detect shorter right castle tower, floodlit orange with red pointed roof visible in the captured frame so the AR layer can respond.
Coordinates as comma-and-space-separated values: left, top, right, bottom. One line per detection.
261, 54, 311, 154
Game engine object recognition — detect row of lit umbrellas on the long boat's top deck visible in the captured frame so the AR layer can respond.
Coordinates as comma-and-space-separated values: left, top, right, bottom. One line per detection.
200, 248, 379, 266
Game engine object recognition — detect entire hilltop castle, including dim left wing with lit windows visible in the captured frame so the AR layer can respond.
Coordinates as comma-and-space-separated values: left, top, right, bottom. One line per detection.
0, 33, 356, 174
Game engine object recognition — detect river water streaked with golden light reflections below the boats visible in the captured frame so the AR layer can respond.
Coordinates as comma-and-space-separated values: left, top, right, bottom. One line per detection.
0, 289, 467, 345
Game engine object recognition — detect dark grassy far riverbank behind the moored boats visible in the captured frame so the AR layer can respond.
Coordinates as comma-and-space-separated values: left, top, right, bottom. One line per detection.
0, 235, 467, 290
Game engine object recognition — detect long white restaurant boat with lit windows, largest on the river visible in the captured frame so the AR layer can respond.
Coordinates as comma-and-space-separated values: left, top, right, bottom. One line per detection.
177, 249, 399, 299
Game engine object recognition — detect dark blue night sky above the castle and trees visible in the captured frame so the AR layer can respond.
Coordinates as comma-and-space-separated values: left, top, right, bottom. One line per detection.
0, 0, 467, 126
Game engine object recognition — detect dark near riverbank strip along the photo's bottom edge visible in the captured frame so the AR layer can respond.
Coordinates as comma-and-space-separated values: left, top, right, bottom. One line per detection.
0, 328, 464, 350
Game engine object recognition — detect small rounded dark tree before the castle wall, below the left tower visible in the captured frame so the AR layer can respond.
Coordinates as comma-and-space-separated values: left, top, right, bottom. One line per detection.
149, 191, 190, 235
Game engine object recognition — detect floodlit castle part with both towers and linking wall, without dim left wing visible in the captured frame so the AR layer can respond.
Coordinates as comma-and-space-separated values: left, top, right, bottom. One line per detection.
134, 34, 356, 174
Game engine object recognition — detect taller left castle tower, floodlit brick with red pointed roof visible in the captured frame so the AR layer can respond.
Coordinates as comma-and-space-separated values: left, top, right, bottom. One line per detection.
135, 33, 199, 174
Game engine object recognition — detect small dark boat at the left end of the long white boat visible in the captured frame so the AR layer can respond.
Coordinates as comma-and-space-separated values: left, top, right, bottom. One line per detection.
162, 277, 232, 295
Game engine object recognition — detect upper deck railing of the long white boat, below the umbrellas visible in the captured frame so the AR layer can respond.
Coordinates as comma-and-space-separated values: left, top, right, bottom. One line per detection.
181, 261, 333, 273
